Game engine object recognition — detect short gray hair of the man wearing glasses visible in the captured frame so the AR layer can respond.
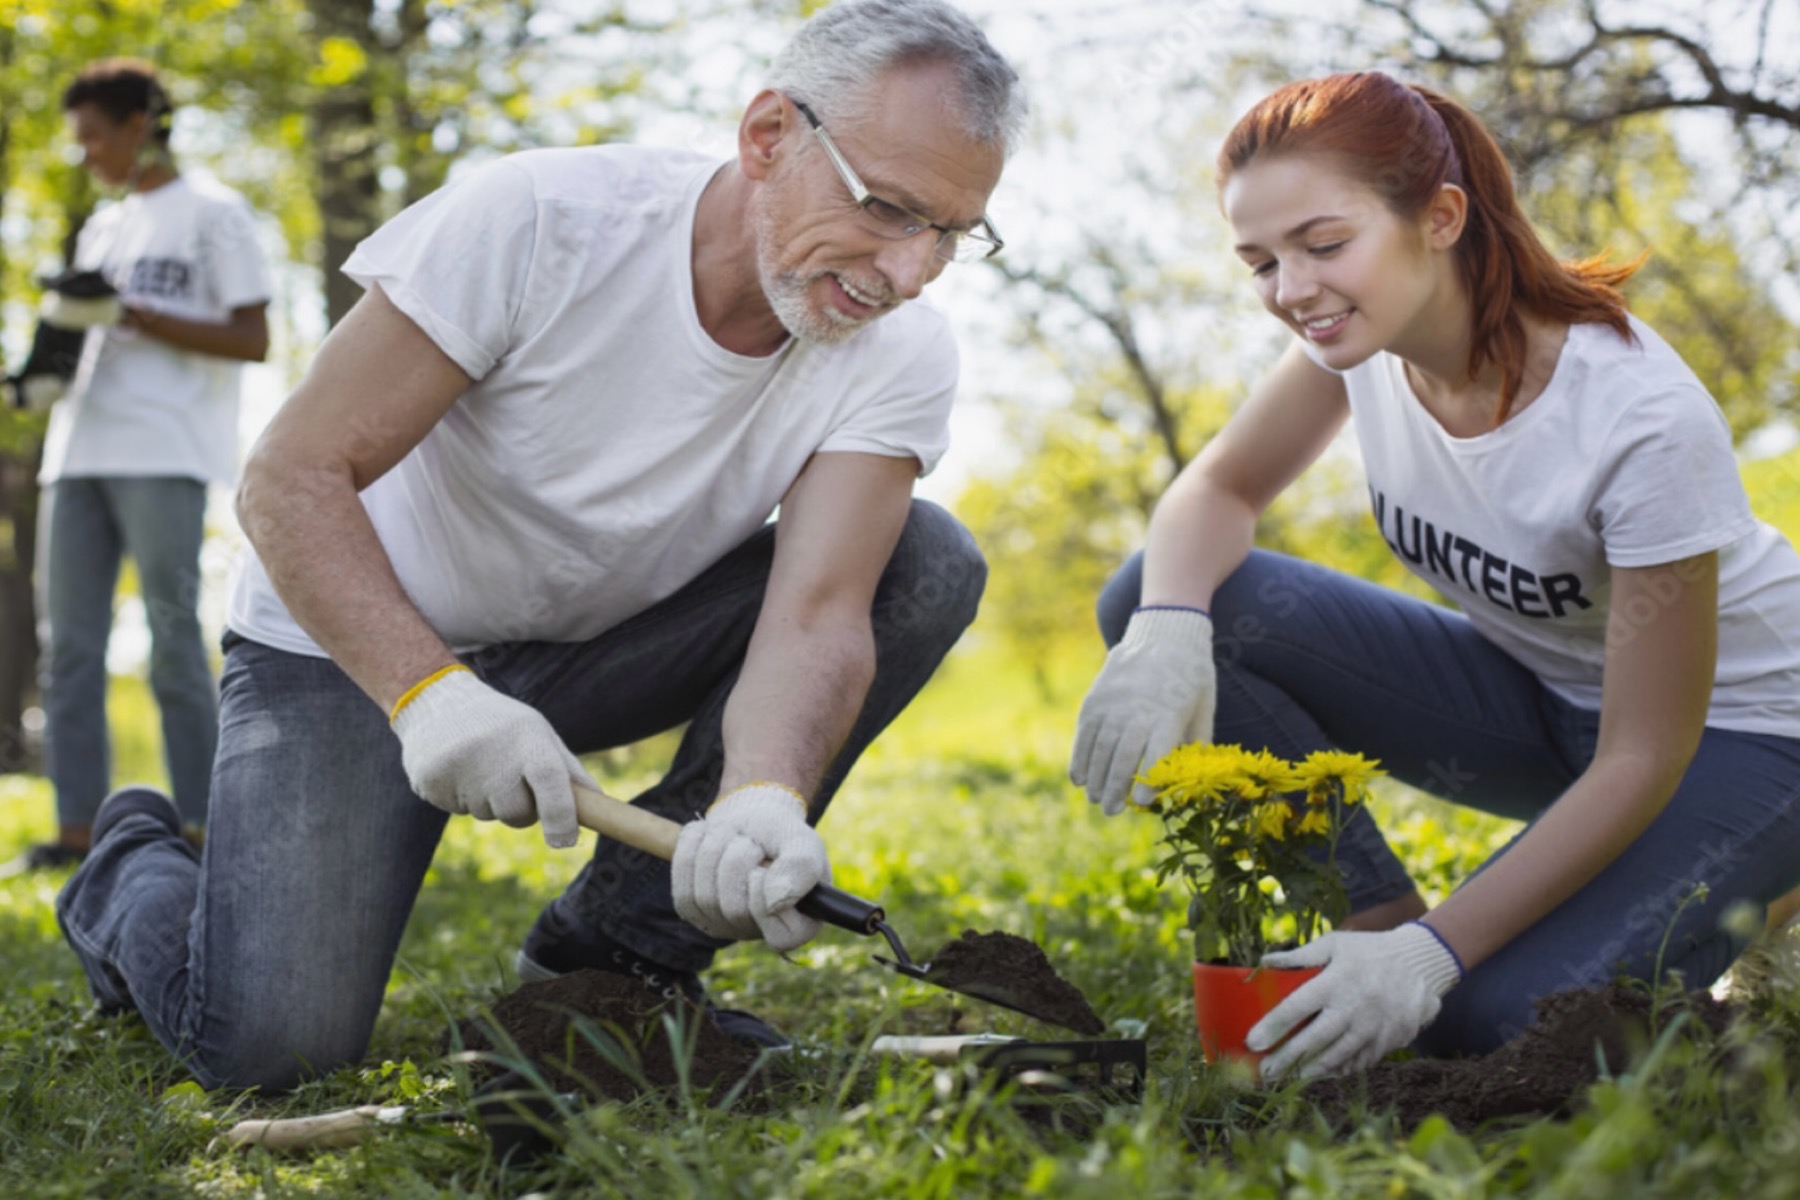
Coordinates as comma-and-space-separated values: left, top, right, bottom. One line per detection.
769, 0, 1026, 155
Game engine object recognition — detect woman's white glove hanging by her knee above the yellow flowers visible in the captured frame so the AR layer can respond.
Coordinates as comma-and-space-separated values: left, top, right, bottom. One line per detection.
1069, 606, 1219, 817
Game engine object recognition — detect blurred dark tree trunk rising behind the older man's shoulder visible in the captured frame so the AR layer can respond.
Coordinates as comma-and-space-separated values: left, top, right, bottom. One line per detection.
308, 0, 382, 326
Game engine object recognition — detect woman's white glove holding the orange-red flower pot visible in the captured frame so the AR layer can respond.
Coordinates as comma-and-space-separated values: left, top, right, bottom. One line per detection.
1244, 921, 1463, 1081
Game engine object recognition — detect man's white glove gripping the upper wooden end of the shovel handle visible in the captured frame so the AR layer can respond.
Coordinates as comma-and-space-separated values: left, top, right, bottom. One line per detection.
392, 667, 598, 849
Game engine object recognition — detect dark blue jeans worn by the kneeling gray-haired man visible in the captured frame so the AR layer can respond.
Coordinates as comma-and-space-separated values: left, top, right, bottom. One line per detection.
58, 502, 986, 1087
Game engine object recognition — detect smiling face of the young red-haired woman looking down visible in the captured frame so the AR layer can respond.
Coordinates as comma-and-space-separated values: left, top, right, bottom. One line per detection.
1222, 155, 1460, 371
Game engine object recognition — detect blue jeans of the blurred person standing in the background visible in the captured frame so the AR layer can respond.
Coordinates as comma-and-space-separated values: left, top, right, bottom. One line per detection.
40, 477, 218, 828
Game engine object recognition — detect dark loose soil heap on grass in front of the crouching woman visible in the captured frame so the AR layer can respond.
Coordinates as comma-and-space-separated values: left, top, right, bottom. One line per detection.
1301, 984, 1732, 1132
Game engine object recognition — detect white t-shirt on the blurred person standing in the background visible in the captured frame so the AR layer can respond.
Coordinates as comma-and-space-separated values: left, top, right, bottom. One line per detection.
38, 176, 268, 484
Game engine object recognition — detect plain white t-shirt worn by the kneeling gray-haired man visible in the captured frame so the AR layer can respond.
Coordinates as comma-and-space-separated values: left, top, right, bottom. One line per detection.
229, 146, 958, 655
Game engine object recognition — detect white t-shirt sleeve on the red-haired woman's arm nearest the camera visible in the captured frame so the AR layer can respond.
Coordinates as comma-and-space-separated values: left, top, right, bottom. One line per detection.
1589, 387, 1755, 567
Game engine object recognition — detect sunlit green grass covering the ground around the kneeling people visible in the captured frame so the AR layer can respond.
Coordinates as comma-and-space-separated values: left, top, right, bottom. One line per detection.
0, 446, 1800, 1200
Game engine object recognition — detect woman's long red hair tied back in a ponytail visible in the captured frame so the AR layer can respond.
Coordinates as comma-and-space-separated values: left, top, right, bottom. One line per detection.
1219, 72, 1647, 425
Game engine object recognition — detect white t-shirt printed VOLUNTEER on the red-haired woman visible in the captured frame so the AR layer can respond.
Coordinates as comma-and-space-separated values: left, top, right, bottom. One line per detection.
1343, 320, 1800, 738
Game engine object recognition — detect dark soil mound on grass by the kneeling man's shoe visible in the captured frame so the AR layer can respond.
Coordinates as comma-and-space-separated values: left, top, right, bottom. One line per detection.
461, 972, 758, 1101
